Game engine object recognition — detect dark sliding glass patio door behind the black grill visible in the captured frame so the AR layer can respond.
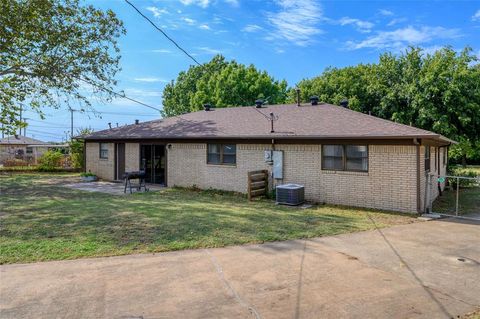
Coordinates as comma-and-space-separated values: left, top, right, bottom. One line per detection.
140, 145, 165, 185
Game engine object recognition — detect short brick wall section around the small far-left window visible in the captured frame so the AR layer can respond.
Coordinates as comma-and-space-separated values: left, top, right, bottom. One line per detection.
85, 143, 115, 180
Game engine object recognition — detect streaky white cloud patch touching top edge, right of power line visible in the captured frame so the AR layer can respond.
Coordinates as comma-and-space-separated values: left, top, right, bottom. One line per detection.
266, 0, 322, 46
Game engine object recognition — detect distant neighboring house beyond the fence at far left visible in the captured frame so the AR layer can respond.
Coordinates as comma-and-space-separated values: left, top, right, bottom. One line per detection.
0, 135, 68, 164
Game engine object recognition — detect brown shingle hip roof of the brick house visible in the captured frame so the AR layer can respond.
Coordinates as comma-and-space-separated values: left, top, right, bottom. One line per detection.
86, 104, 449, 141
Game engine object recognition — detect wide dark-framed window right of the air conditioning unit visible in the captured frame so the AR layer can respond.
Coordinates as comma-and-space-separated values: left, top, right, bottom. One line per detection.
322, 145, 368, 172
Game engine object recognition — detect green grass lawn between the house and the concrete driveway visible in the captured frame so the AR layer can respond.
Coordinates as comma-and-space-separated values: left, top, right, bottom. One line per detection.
0, 173, 415, 264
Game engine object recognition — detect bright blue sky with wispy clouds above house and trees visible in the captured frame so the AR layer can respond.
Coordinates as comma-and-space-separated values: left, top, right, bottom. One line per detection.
26, 0, 480, 141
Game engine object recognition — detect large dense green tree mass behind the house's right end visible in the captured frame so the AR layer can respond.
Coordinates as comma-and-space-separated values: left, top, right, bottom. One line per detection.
289, 47, 480, 165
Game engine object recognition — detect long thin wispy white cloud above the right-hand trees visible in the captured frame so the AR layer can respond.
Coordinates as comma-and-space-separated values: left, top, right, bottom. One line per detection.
347, 26, 461, 50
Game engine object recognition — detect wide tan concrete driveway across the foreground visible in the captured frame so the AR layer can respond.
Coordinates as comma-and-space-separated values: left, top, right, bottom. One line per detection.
0, 219, 480, 318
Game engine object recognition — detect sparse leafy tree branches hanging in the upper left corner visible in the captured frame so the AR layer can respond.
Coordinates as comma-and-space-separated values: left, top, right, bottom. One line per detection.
0, 0, 125, 134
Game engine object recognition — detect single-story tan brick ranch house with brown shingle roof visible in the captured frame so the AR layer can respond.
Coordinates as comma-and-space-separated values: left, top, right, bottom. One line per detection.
85, 102, 453, 213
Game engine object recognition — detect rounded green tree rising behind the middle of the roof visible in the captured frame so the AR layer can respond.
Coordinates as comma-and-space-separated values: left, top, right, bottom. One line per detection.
163, 55, 287, 116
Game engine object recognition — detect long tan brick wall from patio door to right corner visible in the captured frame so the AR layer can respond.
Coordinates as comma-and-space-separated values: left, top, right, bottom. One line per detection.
167, 143, 416, 212
